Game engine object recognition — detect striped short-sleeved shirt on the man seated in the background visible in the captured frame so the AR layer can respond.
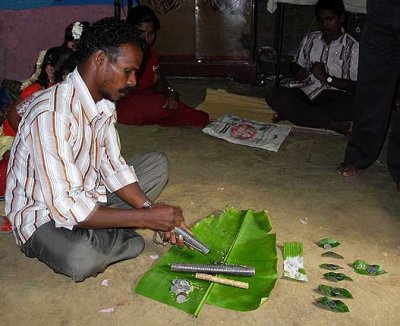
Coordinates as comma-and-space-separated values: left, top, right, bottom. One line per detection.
294, 31, 359, 99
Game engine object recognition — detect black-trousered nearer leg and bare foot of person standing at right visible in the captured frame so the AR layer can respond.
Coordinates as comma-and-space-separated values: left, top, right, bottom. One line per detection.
341, 0, 400, 176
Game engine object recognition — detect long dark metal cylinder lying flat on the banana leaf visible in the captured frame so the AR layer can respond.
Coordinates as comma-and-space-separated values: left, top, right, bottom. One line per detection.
171, 263, 256, 276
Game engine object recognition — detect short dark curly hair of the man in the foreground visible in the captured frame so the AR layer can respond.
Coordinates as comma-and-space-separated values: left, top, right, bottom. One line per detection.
80, 17, 146, 61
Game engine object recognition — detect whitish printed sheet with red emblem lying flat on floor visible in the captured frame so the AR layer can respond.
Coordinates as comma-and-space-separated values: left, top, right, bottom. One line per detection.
203, 115, 290, 152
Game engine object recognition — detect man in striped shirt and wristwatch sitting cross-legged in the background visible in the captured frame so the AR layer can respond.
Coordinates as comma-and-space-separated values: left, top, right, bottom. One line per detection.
266, 0, 359, 136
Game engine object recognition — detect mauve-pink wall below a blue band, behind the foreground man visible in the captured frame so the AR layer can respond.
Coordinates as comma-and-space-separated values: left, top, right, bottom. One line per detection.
0, 5, 114, 80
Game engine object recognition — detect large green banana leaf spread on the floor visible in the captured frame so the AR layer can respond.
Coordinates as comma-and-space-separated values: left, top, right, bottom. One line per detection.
134, 208, 277, 316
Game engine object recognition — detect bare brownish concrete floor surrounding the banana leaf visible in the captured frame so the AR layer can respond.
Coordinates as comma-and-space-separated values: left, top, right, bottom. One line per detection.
0, 79, 400, 326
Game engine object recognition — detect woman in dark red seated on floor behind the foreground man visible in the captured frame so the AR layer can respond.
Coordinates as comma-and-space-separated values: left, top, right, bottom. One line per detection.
116, 6, 209, 128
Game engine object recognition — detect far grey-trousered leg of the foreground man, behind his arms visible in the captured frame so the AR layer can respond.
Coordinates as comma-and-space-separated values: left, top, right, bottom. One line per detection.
107, 152, 169, 208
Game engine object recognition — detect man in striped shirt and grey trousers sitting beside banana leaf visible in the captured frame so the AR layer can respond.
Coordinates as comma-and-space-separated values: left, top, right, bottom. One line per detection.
6, 18, 186, 282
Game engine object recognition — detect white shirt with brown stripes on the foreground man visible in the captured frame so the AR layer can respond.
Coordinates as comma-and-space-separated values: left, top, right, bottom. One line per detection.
5, 69, 138, 245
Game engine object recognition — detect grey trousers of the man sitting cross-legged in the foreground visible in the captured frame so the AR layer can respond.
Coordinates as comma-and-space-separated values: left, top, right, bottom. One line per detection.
21, 153, 168, 282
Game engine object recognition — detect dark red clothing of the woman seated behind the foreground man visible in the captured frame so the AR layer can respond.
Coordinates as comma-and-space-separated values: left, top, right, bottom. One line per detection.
117, 48, 209, 128
